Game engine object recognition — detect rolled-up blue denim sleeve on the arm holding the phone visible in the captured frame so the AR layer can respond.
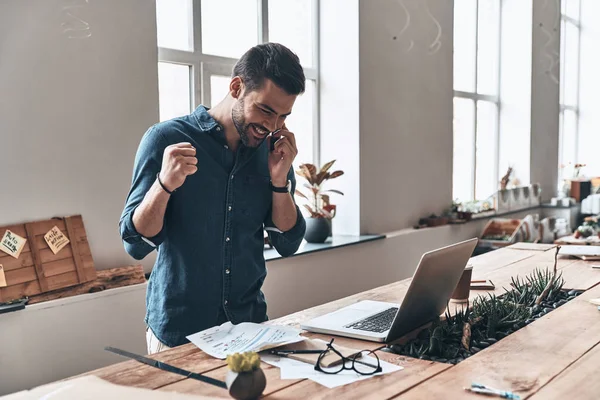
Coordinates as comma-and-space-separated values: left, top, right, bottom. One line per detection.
265, 168, 306, 257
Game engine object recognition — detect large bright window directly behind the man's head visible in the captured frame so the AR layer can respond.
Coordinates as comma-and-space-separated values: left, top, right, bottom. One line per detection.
156, 0, 319, 163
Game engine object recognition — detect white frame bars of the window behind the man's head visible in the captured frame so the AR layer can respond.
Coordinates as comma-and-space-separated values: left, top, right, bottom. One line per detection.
158, 0, 320, 165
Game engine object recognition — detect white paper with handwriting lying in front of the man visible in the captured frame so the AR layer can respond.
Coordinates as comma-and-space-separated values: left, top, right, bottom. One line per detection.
187, 322, 305, 359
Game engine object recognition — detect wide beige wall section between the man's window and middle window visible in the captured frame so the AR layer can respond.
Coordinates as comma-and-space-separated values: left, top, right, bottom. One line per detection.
359, 0, 453, 233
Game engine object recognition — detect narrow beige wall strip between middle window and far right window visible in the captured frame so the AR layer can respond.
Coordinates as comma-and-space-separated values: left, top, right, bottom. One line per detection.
531, 1, 560, 200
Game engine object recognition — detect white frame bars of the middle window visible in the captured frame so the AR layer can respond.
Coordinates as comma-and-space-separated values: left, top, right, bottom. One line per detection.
452, 0, 503, 201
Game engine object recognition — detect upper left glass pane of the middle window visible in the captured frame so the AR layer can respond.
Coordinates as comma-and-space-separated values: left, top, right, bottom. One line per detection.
454, 0, 477, 92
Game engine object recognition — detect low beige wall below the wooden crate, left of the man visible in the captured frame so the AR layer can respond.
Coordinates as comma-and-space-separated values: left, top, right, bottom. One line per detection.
0, 284, 146, 396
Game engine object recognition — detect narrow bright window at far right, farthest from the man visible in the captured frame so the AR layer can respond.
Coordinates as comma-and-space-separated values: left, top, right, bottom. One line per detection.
558, 0, 581, 184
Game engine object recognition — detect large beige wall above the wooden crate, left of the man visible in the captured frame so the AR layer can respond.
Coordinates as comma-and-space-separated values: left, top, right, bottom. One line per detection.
0, 0, 158, 269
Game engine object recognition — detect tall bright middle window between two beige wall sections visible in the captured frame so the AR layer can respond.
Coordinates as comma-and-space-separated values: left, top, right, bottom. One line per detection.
453, 0, 501, 201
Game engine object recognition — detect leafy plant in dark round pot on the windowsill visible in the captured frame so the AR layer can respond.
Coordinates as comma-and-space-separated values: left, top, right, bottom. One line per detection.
296, 160, 344, 243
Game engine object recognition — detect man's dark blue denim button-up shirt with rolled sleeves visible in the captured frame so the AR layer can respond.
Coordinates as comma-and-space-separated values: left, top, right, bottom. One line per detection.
120, 106, 306, 347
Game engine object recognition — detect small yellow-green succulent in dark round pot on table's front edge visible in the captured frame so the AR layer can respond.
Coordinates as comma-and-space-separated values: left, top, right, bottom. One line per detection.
225, 351, 267, 400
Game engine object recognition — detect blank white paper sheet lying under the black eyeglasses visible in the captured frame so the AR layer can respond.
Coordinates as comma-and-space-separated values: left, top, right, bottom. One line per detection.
261, 354, 404, 389
